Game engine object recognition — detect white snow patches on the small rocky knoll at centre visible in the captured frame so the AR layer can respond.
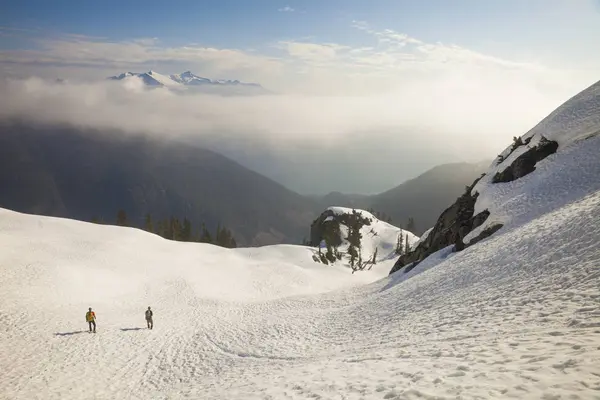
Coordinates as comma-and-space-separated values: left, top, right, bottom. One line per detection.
327, 206, 419, 262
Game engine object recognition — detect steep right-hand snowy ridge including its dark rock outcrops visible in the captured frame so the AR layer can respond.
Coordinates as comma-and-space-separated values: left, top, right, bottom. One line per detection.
391, 82, 600, 272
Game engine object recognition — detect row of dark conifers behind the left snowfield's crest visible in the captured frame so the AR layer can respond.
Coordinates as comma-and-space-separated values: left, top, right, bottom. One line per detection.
92, 210, 237, 249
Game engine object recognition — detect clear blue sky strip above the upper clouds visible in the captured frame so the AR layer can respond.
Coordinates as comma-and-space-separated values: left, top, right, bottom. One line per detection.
0, 0, 600, 69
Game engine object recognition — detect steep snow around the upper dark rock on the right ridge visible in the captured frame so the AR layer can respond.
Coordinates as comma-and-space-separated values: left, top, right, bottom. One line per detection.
465, 82, 600, 243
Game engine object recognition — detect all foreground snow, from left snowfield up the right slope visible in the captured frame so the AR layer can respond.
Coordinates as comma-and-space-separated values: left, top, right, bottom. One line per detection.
0, 79, 600, 400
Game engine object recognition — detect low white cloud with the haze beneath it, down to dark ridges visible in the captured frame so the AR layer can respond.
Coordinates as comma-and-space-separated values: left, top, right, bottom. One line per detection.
0, 75, 573, 192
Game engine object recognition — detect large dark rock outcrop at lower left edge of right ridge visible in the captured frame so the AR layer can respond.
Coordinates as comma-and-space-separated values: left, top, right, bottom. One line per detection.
390, 175, 490, 274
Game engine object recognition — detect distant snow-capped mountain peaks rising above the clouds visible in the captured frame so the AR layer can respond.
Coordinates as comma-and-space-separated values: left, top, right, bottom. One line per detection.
108, 71, 266, 92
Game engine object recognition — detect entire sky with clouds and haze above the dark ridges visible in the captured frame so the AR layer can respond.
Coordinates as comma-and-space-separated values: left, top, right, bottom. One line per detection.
0, 0, 600, 192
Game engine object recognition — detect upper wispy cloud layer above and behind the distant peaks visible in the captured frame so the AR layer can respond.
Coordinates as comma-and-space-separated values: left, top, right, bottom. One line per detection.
0, 21, 593, 95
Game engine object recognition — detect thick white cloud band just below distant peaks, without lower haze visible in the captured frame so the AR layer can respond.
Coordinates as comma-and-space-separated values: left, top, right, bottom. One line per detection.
0, 75, 573, 152
